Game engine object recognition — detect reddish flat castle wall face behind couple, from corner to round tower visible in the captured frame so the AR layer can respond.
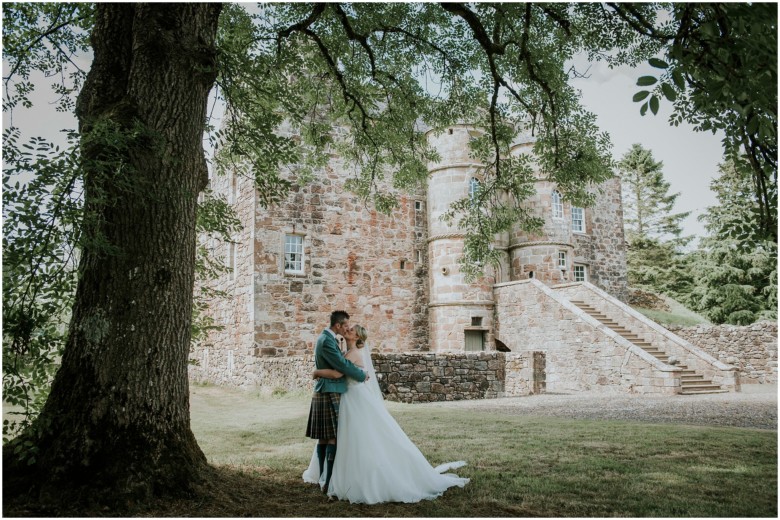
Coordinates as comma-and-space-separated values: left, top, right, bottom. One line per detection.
254, 159, 428, 356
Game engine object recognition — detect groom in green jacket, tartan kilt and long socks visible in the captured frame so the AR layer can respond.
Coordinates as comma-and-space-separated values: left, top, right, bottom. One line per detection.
306, 311, 368, 494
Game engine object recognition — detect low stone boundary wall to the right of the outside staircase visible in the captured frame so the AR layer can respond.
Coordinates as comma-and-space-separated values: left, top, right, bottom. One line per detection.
667, 321, 777, 385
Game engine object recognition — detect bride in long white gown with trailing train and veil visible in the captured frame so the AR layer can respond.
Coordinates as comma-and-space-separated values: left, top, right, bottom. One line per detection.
303, 325, 469, 504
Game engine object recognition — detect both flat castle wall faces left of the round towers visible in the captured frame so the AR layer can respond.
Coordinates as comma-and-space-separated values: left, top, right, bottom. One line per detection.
191, 149, 429, 374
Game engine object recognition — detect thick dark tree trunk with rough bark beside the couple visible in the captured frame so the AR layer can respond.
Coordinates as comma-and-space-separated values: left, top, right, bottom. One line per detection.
4, 3, 220, 506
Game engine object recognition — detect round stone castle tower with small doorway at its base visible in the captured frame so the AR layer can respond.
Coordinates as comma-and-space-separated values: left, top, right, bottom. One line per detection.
427, 125, 495, 352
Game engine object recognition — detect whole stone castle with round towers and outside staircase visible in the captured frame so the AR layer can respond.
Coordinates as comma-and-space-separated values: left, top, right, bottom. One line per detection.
191, 125, 738, 395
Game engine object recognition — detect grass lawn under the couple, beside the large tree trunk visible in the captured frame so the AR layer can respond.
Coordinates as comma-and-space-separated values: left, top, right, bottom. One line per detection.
174, 386, 777, 518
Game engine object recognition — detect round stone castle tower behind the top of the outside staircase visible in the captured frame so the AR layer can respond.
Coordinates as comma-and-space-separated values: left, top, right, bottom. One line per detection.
509, 138, 585, 285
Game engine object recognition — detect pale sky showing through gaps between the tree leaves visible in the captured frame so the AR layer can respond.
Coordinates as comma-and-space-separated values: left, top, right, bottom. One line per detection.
3, 50, 723, 244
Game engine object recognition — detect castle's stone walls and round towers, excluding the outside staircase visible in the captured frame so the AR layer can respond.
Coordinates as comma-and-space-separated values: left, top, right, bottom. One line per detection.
191, 125, 626, 386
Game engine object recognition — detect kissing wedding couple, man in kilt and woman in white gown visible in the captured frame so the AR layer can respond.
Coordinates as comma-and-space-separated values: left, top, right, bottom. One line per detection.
303, 311, 469, 504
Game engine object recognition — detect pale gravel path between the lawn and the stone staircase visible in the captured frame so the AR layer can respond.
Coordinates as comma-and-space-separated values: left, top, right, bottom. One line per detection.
421, 391, 777, 430
